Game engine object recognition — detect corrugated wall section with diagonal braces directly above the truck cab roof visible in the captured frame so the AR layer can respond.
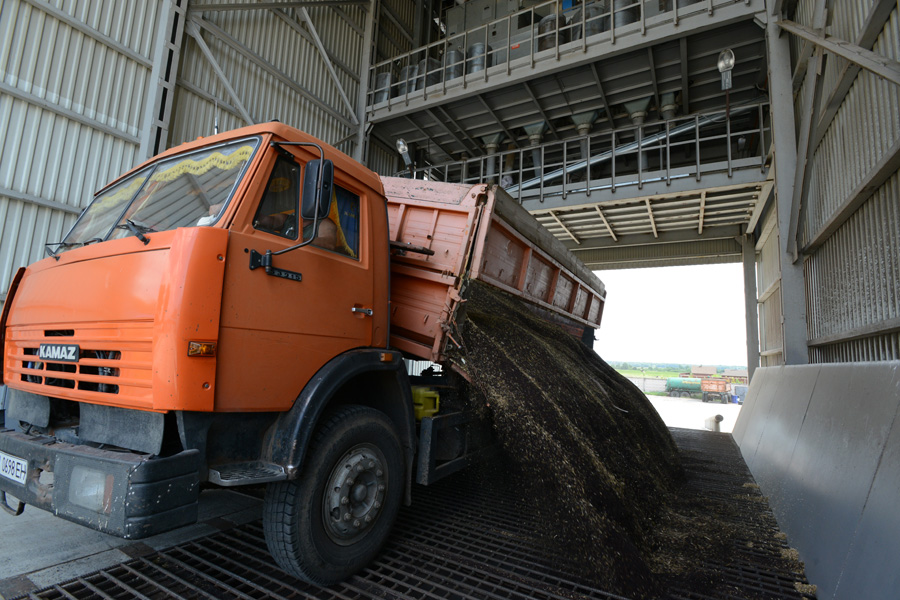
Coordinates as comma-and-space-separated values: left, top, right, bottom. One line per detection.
169, 5, 367, 154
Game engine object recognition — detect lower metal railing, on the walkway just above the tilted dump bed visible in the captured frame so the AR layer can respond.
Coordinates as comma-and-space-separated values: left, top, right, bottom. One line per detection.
403, 102, 772, 202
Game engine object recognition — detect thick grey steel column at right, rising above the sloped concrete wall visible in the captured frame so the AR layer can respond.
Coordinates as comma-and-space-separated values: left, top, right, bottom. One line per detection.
766, 19, 809, 365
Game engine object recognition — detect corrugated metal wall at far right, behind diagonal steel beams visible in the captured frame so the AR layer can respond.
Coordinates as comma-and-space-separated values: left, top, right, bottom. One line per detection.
796, 0, 900, 362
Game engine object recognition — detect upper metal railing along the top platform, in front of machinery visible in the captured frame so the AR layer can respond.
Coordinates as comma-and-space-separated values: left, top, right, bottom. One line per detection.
366, 0, 750, 109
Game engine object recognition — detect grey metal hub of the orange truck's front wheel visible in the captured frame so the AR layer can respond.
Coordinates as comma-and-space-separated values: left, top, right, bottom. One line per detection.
322, 444, 388, 546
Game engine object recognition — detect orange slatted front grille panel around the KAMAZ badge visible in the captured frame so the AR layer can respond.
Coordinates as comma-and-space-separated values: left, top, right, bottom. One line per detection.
6, 323, 153, 408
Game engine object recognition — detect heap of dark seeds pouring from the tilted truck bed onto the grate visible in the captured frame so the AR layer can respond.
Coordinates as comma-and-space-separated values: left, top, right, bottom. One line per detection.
455, 282, 681, 597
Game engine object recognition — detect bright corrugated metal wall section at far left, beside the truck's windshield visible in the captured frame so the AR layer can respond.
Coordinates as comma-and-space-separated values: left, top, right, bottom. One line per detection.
0, 0, 160, 299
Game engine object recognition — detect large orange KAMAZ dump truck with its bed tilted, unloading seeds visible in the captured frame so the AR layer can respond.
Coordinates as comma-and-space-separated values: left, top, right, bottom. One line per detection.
0, 123, 605, 584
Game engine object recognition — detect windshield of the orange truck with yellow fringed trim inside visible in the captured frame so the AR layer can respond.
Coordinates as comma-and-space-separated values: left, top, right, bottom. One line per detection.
60, 138, 259, 250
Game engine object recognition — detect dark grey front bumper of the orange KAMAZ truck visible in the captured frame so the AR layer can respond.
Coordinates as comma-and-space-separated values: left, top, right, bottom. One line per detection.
0, 429, 200, 539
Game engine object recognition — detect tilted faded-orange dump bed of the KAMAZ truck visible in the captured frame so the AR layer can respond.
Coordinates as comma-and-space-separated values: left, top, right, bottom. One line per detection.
382, 177, 606, 362
